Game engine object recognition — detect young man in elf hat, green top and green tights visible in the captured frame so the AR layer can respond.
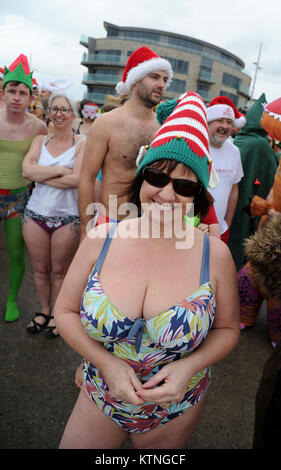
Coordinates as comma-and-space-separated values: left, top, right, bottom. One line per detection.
0, 54, 48, 322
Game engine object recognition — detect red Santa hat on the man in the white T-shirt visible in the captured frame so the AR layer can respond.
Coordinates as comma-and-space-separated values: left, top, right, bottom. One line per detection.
207, 96, 246, 128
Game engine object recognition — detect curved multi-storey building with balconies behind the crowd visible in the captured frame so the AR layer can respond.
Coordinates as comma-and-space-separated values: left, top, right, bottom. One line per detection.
80, 22, 251, 108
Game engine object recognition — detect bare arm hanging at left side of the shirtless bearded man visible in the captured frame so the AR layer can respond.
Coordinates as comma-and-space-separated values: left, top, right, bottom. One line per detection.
78, 115, 110, 240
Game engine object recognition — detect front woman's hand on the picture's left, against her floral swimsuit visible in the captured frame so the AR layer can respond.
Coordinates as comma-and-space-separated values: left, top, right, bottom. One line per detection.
101, 357, 144, 405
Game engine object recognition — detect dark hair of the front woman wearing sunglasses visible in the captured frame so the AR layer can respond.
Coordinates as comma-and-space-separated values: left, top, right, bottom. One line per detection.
126, 160, 214, 217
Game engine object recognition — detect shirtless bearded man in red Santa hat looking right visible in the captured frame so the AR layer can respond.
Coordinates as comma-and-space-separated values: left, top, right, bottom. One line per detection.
79, 47, 173, 239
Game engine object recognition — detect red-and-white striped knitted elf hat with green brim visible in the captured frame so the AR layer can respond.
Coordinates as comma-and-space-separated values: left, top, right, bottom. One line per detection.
136, 92, 218, 188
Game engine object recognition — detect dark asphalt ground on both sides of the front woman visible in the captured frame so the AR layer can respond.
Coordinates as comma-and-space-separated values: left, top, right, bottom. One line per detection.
0, 225, 271, 449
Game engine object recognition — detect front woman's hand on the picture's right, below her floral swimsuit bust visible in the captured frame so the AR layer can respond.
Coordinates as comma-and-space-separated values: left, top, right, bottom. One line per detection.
136, 359, 193, 404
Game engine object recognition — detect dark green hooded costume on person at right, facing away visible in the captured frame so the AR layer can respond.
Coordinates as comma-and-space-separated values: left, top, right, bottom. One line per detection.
228, 94, 277, 271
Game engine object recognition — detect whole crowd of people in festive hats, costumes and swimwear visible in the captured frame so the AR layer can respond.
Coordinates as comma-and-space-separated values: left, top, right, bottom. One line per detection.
0, 47, 281, 449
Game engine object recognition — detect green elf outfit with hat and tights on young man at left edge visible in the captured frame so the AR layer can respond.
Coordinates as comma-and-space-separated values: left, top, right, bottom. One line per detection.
0, 54, 35, 322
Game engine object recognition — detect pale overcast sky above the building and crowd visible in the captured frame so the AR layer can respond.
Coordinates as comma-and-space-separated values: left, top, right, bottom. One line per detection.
0, 0, 281, 102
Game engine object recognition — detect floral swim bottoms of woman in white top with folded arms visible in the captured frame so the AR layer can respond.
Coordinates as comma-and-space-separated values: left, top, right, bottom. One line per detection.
22, 209, 80, 236
